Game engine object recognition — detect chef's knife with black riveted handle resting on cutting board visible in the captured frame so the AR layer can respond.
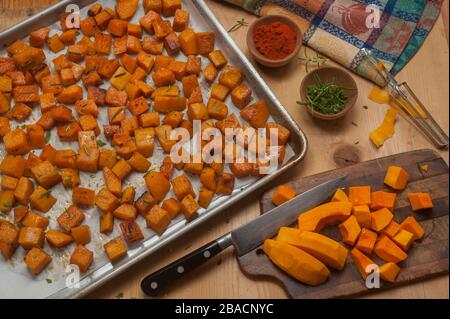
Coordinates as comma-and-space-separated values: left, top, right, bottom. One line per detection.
141, 176, 345, 297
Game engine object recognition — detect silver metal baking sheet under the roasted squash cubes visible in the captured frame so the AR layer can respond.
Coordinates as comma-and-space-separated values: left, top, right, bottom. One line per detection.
0, 0, 307, 298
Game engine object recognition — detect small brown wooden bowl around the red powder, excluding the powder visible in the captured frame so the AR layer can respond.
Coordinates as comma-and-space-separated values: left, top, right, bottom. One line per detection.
247, 15, 303, 68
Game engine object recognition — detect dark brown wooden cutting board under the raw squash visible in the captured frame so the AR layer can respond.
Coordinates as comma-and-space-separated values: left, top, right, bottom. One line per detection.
238, 150, 449, 298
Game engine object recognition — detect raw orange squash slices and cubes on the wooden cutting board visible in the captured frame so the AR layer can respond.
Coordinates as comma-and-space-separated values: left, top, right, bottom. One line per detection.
264, 166, 433, 286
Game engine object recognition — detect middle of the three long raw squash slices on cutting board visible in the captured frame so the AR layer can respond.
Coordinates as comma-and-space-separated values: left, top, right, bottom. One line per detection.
276, 227, 348, 270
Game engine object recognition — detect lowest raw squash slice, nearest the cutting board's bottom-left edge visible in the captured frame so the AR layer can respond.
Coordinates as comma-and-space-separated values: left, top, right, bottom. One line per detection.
263, 239, 330, 286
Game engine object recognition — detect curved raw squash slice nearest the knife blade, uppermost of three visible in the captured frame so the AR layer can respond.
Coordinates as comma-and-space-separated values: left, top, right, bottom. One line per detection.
298, 202, 352, 233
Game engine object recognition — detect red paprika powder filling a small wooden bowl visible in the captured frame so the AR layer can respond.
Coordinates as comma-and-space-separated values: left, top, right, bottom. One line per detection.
253, 21, 297, 60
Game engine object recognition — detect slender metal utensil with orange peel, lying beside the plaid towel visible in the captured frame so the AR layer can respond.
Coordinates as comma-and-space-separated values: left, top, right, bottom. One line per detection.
362, 48, 449, 148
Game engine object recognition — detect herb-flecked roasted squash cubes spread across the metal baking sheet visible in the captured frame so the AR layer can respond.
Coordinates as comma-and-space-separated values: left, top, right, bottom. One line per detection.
0, 0, 289, 274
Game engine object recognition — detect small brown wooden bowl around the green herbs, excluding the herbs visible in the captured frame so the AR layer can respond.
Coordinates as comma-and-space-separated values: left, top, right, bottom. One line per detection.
300, 67, 358, 121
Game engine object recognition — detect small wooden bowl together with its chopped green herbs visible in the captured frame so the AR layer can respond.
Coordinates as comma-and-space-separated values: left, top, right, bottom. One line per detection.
297, 67, 358, 121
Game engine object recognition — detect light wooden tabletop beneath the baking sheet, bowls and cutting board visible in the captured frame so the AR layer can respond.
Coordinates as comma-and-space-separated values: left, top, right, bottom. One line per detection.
0, 0, 449, 298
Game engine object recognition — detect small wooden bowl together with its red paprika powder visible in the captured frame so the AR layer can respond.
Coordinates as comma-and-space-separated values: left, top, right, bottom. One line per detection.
247, 15, 303, 67
